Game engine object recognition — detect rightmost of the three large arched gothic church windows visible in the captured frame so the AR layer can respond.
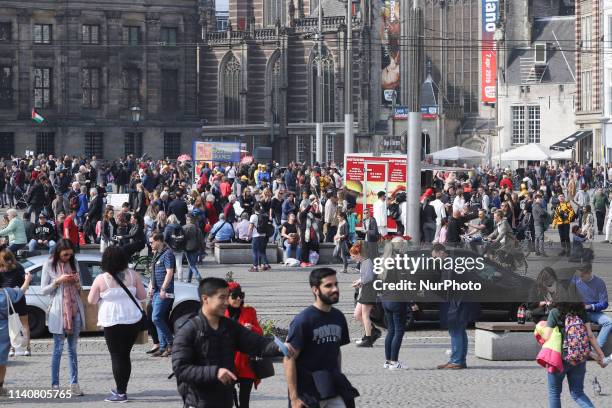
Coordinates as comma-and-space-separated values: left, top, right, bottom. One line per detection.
310, 48, 336, 122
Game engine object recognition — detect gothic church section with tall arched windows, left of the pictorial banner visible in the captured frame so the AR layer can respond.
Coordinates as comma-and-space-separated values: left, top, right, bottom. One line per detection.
199, 0, 372, 162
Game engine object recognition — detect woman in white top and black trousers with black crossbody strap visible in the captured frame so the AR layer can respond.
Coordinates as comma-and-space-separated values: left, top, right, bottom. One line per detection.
87, 246, 147, 402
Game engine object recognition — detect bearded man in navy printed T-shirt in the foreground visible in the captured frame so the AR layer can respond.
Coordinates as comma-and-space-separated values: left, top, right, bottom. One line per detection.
284, 268, 359, 408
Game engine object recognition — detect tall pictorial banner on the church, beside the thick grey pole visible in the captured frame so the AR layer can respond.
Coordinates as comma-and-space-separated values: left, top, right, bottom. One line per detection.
380, 0, 401, 103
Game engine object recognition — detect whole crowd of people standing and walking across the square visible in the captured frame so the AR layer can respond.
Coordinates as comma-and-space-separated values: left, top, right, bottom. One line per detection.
0, 156, 612, 407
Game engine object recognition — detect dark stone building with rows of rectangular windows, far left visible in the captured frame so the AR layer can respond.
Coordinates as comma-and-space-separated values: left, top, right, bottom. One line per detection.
0, 0, 201, 159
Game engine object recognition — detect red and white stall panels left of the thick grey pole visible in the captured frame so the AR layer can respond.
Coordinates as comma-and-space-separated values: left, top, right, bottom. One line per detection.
345, 153, 407, 231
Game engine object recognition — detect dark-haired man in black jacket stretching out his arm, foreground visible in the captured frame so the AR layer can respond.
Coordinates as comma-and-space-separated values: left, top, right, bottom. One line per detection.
172, 278, 292, 408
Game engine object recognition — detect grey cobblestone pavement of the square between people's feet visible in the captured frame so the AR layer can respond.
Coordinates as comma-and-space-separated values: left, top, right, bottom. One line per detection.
0, 264, 612, 408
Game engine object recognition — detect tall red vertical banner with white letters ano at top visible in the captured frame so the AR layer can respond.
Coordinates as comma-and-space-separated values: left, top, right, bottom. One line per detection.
480, 0, 499, 103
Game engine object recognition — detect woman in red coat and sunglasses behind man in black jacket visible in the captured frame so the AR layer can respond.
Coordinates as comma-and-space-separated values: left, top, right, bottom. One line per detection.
225, 282, 263, 408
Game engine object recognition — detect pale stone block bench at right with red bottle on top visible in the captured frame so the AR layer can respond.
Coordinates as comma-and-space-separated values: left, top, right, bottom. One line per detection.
475, 322, 612, 361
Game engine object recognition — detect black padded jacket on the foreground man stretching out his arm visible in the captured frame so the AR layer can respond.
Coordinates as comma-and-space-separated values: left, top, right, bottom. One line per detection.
172, 312, 279, 408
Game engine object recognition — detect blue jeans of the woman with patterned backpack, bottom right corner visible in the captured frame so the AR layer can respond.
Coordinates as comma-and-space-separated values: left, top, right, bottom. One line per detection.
548, 361, 593, 408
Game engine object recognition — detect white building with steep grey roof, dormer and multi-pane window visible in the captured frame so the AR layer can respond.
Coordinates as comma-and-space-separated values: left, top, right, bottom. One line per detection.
498, 16, 577, 164
